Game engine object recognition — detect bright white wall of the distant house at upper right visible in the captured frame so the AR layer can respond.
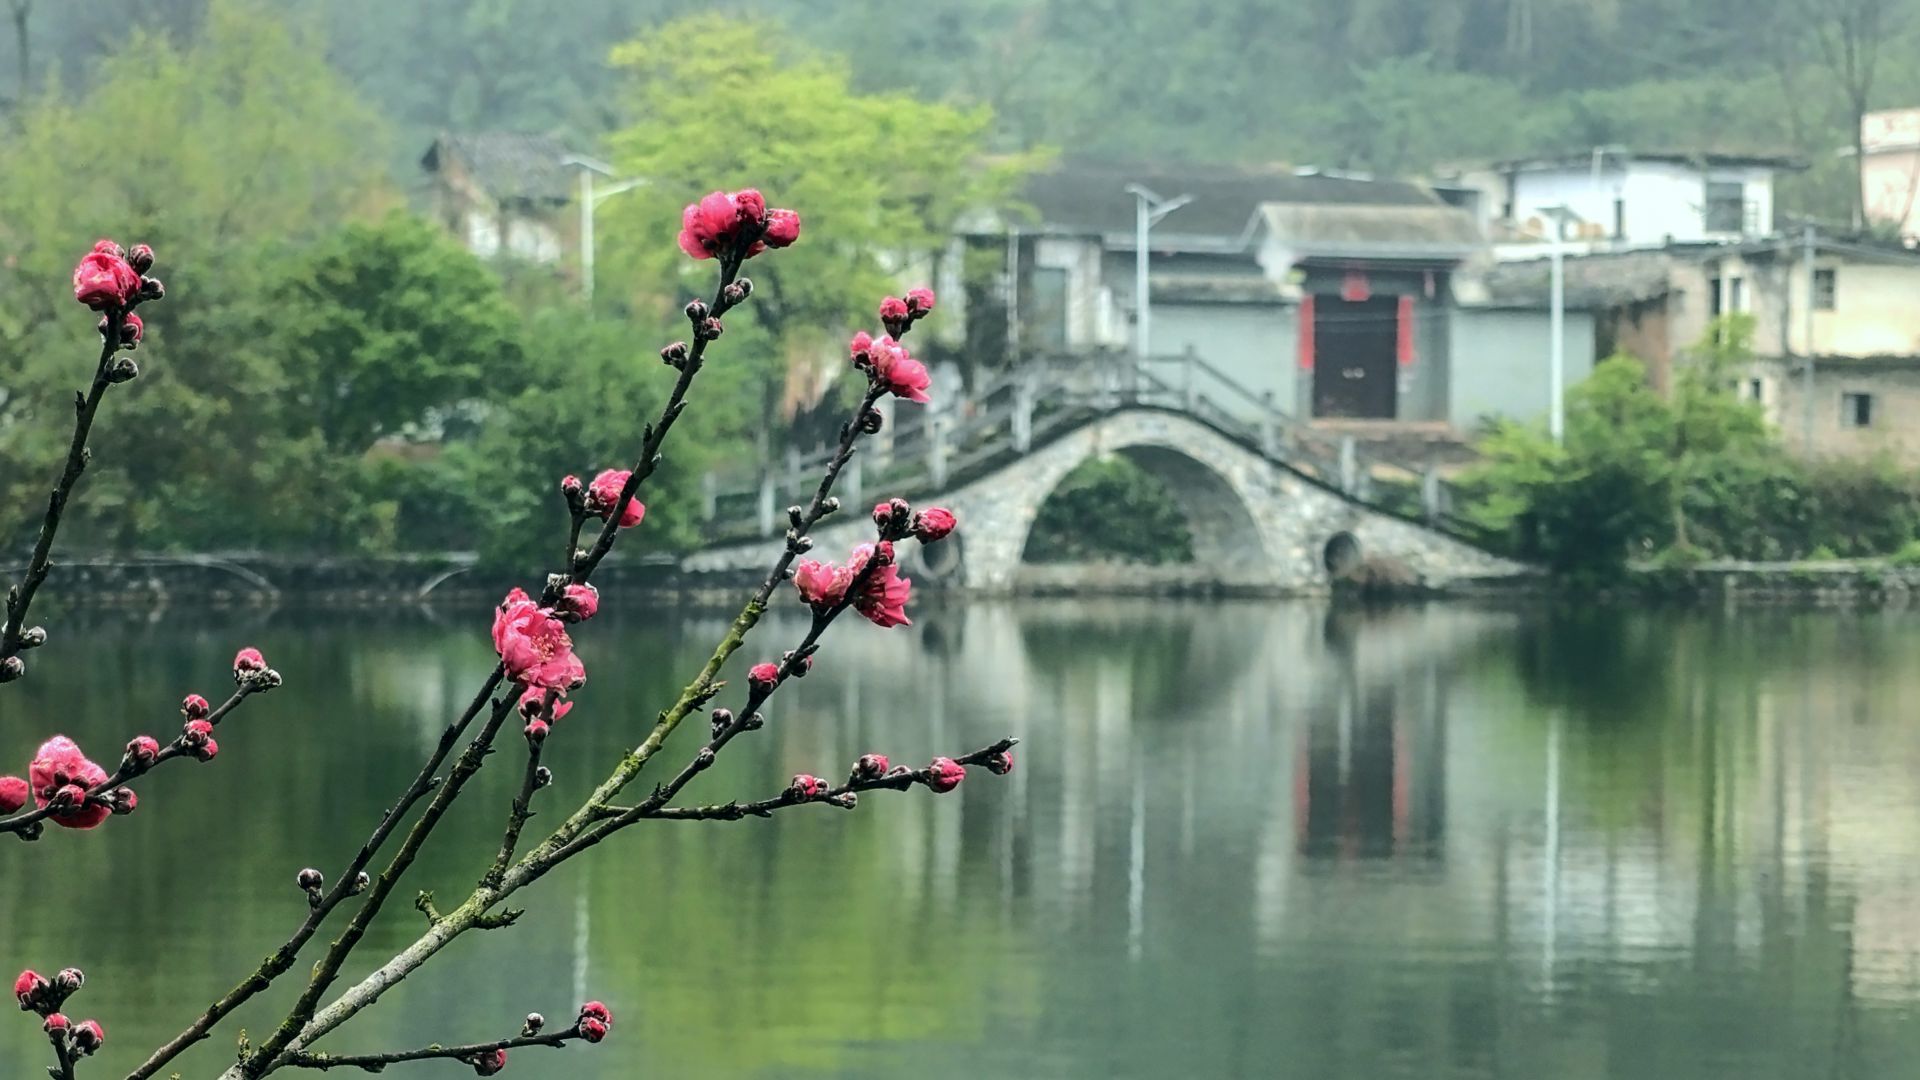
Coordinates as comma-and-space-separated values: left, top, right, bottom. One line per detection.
1513, 161, 1774, 244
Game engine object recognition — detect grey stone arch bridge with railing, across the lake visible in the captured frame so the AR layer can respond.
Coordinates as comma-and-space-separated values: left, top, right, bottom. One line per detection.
685, 356, 1528, 594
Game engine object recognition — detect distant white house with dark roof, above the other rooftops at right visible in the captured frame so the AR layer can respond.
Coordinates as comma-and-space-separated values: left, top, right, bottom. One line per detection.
1440, 146, 1805, 248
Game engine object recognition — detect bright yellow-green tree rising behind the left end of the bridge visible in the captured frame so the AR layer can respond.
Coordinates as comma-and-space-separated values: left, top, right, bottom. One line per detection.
603, 15, 1029, 457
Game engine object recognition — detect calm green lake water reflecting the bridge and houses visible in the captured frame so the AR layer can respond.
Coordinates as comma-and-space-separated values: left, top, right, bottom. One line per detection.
0, 601, 1920, 1080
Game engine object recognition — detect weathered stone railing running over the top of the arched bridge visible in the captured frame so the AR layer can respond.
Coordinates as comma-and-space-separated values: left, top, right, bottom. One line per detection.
703, 352, 1455, 536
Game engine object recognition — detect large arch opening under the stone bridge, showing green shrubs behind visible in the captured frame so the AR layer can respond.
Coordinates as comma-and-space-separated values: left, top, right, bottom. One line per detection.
1021, 444, 1267, 573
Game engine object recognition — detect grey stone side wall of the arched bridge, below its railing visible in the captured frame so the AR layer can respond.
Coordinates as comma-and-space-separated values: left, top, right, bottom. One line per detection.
684, 409, 1530, 594
